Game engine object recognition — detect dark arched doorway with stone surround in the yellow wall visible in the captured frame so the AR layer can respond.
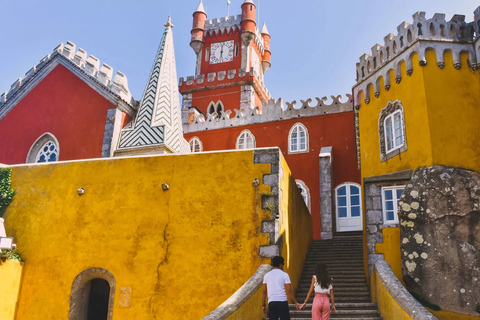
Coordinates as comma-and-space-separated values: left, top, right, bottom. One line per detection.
69, 268, 115, 320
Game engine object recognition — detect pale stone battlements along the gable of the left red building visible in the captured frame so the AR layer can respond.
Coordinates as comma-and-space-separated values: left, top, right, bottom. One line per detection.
0, 41, 132, 108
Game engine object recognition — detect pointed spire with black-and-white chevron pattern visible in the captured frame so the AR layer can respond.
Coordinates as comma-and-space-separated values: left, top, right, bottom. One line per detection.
116, 17, 189, 155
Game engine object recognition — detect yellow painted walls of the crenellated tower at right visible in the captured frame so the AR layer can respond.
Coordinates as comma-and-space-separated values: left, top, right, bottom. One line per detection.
358, 51, 480, 280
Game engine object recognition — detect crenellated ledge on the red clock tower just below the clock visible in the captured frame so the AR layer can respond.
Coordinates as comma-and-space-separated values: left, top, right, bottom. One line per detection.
178, 68, 272, 99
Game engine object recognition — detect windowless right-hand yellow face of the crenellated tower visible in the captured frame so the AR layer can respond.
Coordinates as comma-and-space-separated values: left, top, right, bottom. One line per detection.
423, 52, 480, 171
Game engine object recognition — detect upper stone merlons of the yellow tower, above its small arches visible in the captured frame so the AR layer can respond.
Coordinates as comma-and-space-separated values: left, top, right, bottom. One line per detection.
356, 7, 480, 83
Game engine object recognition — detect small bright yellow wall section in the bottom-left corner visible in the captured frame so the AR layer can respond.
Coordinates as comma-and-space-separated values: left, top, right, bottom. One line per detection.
0, 260, 23, 320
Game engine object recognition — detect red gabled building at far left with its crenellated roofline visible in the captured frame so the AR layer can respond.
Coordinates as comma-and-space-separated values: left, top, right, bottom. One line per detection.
0, 42, 135, 164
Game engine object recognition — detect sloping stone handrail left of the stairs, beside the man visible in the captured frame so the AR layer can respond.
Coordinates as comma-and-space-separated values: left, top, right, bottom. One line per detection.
202, 264, 272, 320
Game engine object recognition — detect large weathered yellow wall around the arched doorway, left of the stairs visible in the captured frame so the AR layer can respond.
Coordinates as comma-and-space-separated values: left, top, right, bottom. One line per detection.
0, 149, 312, 320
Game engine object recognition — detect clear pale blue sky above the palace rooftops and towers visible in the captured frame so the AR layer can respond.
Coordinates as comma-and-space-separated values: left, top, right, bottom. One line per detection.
0, 0, 480, 101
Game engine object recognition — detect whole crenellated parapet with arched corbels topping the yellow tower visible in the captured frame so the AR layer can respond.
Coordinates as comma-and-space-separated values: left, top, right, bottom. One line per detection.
354, 7, 480, 104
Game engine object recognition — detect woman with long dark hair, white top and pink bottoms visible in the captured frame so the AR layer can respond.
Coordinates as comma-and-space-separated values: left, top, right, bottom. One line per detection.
301, 263, 336, 320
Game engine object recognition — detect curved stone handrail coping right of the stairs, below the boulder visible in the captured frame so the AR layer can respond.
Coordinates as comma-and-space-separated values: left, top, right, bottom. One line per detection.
375, 260, 438, 320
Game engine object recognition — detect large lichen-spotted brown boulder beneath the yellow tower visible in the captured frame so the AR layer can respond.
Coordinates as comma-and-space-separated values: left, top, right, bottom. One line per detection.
398, 166, 480, 316
